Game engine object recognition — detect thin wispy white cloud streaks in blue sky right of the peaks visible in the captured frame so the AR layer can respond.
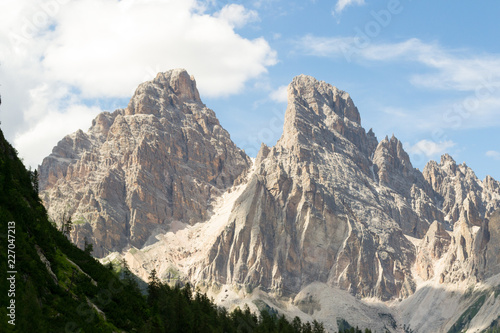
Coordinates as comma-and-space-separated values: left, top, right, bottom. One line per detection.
296, 35, 500, 131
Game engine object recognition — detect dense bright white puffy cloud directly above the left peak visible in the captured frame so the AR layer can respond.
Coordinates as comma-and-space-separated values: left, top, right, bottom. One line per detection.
43, 0, 276, 97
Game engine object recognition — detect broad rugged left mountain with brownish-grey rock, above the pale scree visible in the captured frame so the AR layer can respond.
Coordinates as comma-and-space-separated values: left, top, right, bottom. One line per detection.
40, 70, 251, 256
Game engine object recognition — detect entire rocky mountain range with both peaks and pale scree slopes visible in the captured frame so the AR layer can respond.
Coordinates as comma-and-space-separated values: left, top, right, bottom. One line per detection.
38, 69, 500, 332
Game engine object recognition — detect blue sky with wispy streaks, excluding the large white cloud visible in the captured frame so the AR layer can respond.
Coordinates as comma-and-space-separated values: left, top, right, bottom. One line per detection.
206, 0, 500, 179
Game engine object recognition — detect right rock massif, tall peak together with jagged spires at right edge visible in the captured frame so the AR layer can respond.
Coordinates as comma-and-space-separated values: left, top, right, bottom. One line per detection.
196, 75, 500, 300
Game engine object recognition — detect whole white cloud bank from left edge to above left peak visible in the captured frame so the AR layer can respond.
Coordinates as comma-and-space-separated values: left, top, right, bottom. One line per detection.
0, 0, 277, 166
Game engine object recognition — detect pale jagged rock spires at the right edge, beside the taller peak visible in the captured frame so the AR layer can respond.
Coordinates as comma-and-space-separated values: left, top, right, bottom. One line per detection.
417, 155, 500, 283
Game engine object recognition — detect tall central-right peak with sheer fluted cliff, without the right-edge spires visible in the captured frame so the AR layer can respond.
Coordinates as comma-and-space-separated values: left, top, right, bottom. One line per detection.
200, 76, 420, 299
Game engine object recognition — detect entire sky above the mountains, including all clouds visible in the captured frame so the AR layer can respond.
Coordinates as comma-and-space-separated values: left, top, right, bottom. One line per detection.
0, 0, 500, 179
